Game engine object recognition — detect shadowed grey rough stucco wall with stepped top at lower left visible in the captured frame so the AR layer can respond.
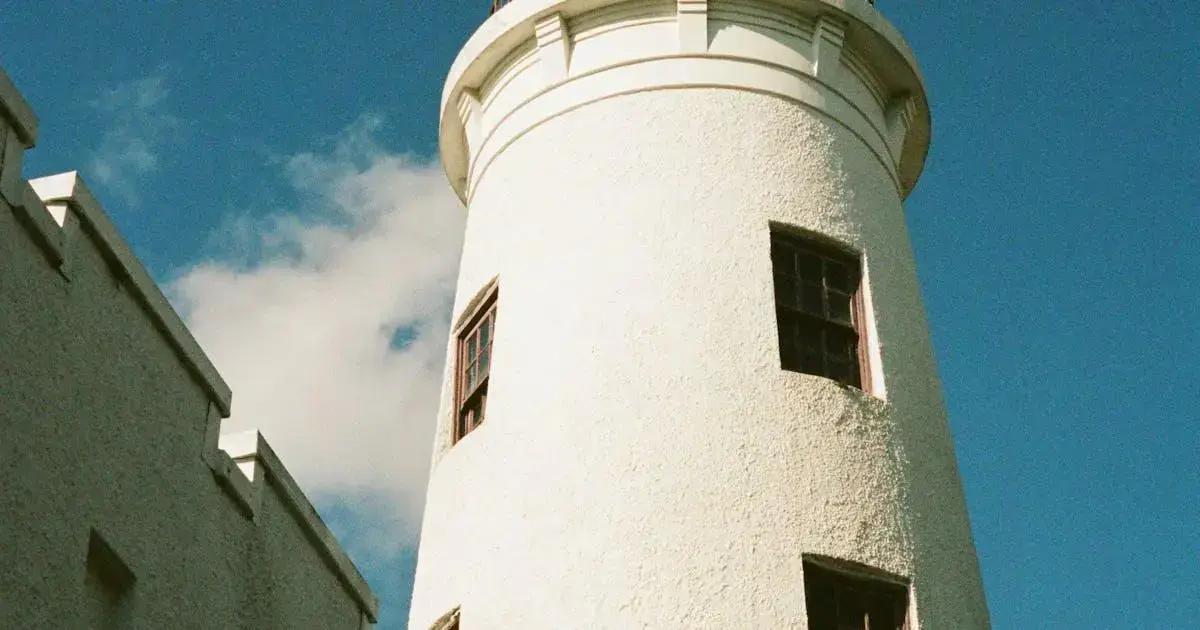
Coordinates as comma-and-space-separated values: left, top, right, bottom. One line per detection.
0, 98, 373, 629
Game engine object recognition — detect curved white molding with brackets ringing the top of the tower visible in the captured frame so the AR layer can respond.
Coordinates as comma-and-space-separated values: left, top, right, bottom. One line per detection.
439, 0, 930, 203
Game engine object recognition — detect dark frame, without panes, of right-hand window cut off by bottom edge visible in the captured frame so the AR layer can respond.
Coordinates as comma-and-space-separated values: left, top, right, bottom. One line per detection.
802, 554, 912, 630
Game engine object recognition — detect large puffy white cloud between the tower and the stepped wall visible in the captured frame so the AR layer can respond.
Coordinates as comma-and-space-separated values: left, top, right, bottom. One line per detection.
170, 118, 464, 551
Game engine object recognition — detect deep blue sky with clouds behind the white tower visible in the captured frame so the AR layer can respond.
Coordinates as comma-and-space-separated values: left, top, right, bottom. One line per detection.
0, 0, 1200, 628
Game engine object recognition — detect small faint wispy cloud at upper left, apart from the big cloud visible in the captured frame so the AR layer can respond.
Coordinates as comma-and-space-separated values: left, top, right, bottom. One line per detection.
88, 76, 180, 203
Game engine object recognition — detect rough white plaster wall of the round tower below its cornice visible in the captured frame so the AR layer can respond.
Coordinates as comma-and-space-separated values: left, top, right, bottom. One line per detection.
410, 2, 989, 630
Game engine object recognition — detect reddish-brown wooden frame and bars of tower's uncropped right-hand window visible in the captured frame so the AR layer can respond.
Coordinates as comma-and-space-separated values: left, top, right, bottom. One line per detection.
770, 224, 872, 392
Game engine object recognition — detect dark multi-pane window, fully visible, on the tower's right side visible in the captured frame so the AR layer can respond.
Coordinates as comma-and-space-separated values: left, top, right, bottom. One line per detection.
770, 232, 869, 390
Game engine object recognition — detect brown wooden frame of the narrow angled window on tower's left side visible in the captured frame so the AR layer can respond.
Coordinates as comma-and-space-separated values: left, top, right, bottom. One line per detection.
451, 284, 499, 444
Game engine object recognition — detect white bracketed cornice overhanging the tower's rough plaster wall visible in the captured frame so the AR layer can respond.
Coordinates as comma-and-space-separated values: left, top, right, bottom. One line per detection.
440, 0, 930, 202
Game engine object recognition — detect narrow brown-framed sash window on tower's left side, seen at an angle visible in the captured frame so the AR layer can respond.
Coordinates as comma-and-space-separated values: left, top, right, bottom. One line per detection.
454, 287, 497, 442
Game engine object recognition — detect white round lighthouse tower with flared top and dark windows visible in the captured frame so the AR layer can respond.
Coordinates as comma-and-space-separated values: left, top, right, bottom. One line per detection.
410, 0, 989, 630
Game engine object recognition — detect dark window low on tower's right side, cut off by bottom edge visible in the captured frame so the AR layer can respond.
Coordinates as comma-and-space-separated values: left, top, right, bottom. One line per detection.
804, 560, 908, 630
